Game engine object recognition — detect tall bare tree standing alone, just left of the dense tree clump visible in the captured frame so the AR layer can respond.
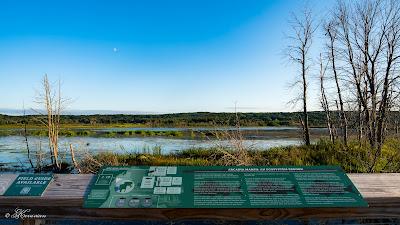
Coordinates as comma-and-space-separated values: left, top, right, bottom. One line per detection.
286, 8, 316, 145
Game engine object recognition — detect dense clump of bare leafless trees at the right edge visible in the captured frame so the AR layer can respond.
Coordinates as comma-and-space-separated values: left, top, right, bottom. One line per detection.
325, 0, 400, 171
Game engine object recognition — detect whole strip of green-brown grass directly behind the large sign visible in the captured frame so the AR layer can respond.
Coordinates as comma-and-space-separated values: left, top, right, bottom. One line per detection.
79, 138, 400, 173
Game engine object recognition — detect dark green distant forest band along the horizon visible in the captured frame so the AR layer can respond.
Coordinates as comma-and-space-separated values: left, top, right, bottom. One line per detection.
0, 111, 334, 127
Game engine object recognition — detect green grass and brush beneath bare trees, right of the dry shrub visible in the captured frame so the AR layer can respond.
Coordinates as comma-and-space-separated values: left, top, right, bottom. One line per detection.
254, 138, 400, 173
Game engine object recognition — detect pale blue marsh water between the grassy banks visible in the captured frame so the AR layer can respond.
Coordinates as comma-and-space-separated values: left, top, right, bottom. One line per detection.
0, 127, 323, 168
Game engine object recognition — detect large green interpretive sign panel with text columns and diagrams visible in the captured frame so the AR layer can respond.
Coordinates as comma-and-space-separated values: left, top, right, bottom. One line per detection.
84, 166, 368, 208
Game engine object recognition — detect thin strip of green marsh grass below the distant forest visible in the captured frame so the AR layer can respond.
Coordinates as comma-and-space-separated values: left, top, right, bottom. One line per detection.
0, 127, 328, 140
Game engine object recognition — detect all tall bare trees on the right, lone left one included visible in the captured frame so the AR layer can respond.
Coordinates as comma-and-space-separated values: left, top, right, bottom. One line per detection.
287, 0, 400, 172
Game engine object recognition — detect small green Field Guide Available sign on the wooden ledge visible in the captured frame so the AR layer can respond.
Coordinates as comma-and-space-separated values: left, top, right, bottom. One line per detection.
4, 174, 53, 196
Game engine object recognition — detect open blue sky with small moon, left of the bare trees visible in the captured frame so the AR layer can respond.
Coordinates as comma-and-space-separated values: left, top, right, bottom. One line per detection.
0, 0, 333, 113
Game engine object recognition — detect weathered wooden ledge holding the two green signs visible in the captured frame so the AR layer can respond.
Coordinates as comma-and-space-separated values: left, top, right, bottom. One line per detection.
0, 174, 400, 220
